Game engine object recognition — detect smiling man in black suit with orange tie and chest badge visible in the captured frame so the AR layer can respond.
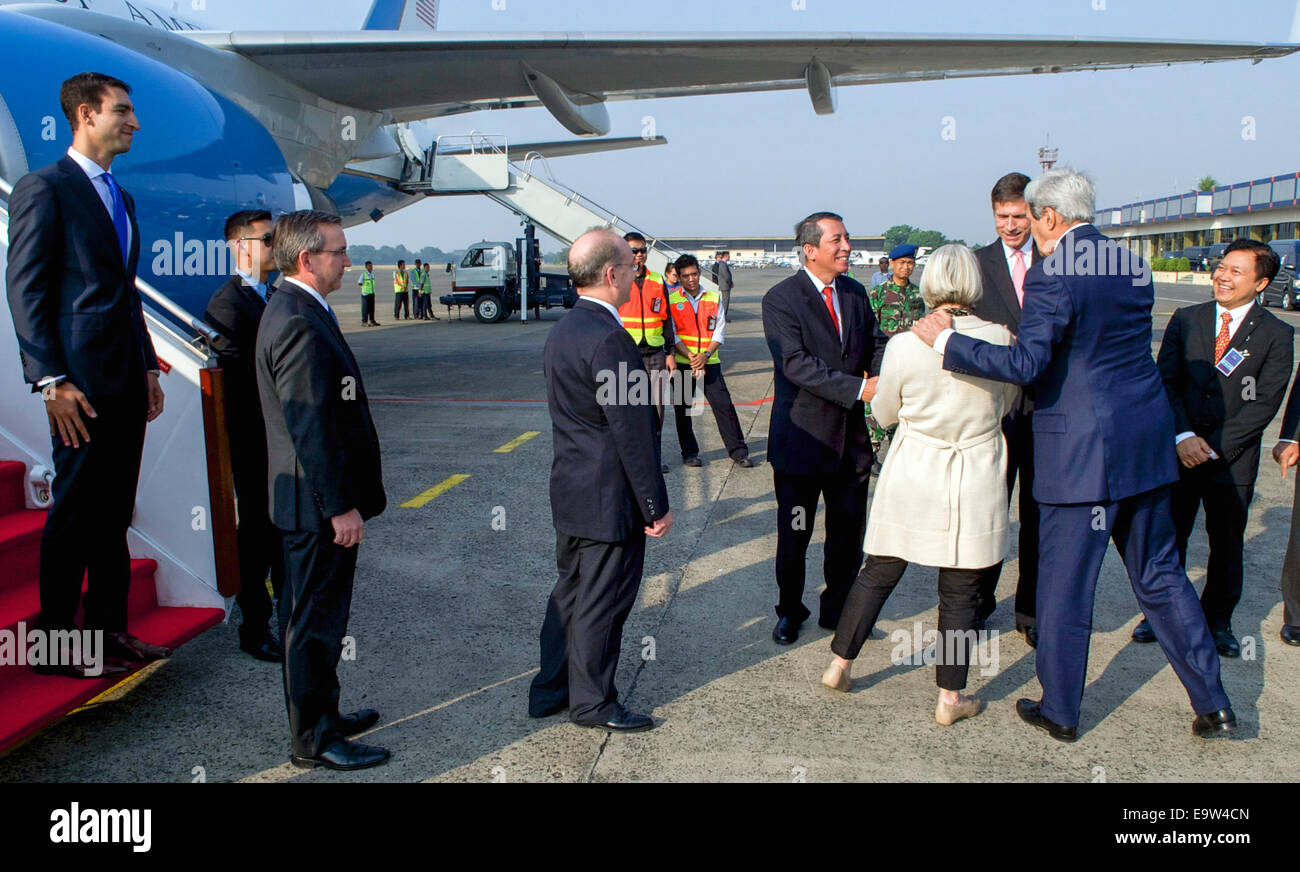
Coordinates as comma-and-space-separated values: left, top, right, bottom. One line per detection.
1154, 239, 1295, 658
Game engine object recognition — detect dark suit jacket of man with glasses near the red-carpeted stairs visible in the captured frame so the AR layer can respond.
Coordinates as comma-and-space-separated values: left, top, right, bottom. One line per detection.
256, 281, 387, 533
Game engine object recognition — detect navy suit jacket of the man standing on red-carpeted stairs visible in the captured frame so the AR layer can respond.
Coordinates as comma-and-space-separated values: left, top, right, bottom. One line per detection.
5, 155, 159, 398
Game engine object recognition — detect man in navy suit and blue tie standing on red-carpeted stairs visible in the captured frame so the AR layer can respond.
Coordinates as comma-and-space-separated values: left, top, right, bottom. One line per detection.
5, 73, 170, 678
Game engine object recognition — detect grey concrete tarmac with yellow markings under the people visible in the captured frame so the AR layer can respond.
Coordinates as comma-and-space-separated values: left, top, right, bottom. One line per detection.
0, 269, 1300, 782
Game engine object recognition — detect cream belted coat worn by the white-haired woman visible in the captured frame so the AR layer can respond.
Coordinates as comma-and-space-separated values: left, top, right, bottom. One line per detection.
863, 316, 1019, 569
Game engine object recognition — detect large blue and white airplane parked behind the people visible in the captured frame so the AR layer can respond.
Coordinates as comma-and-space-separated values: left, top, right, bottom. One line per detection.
0, 0, 1300, 312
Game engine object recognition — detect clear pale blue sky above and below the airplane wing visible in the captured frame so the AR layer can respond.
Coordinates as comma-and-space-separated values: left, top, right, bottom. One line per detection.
197, 0, 1300, 250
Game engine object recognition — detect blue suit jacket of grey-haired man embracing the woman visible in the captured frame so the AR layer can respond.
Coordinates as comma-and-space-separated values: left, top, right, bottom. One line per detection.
944, 225, 1178, 506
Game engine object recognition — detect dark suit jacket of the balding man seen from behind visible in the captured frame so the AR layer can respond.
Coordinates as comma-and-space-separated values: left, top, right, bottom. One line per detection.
542, 299, 668, 542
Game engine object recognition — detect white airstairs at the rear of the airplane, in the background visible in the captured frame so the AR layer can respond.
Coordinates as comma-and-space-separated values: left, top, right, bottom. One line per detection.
399, 133, 716, 290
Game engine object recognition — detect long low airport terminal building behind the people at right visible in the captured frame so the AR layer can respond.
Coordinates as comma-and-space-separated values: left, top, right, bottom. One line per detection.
1096, 173, 1300, 257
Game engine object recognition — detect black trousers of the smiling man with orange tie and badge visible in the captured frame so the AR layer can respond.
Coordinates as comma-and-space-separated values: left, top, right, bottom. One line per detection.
1170, 467, 1255, 630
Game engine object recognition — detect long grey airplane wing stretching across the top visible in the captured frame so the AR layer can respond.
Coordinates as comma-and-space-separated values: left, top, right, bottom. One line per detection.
185, 30, 1300, 134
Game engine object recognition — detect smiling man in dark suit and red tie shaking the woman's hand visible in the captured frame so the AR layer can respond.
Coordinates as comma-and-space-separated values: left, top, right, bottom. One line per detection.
763, 212, 887, 645
